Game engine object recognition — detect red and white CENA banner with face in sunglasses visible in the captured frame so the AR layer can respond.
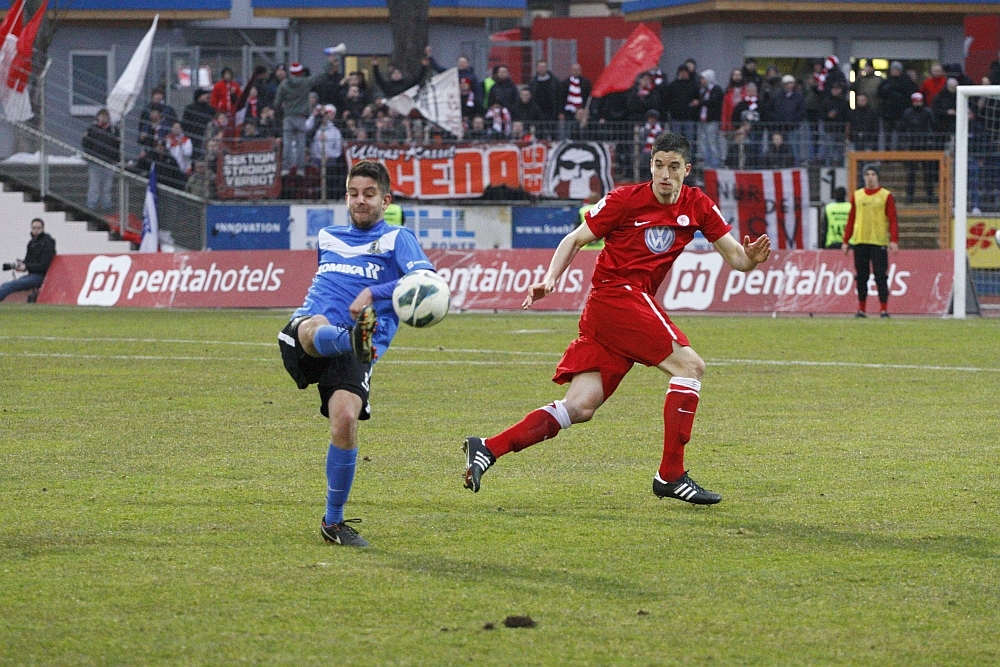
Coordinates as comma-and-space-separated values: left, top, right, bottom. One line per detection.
346, 141, 614, 200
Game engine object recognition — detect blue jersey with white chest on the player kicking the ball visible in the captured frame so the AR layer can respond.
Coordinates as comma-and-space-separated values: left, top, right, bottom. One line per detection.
293, 220, 434, 355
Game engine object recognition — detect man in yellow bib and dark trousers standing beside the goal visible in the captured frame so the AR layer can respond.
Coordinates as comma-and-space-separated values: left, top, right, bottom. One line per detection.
841, 164, 899, 317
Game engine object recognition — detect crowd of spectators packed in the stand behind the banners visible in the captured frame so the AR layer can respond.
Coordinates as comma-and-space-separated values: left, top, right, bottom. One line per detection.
78, 47, 1000, 210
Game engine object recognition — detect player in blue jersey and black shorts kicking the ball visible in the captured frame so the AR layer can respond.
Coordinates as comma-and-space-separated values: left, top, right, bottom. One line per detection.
278, 161, 434, 547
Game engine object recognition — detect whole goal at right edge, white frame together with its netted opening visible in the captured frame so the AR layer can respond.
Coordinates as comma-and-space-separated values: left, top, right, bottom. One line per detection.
953, 86, 1000, 318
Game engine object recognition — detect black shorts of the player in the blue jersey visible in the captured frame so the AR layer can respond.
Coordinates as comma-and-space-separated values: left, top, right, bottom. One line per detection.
278, 317, 372, 420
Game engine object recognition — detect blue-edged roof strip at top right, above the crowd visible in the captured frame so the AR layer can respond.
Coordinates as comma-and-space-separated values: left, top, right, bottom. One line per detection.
622, 0, 1000, 22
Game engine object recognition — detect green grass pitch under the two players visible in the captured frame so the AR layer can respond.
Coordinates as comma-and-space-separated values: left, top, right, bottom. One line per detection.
0, 305, 1000, 667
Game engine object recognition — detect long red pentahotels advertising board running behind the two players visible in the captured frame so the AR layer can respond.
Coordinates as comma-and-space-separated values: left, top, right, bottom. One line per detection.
38, 249, 952, 315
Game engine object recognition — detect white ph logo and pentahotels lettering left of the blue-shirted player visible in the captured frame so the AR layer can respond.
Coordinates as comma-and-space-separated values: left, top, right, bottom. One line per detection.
76, 255, 285, 306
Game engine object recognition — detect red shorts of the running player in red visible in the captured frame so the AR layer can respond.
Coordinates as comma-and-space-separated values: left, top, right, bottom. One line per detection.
552, 285, 690, 400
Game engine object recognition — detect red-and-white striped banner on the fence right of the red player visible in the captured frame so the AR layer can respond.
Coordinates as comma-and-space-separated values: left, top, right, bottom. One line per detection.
705, 169, 816, 250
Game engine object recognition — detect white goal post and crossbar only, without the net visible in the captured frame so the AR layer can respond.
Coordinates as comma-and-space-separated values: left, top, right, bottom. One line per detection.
952, 86, 1000, 320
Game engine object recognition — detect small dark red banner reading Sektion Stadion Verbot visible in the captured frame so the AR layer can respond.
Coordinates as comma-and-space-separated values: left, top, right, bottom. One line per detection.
215, 139, 281, 199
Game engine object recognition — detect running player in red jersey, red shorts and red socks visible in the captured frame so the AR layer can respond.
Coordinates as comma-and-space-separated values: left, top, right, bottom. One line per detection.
463, 133, 771, 505
